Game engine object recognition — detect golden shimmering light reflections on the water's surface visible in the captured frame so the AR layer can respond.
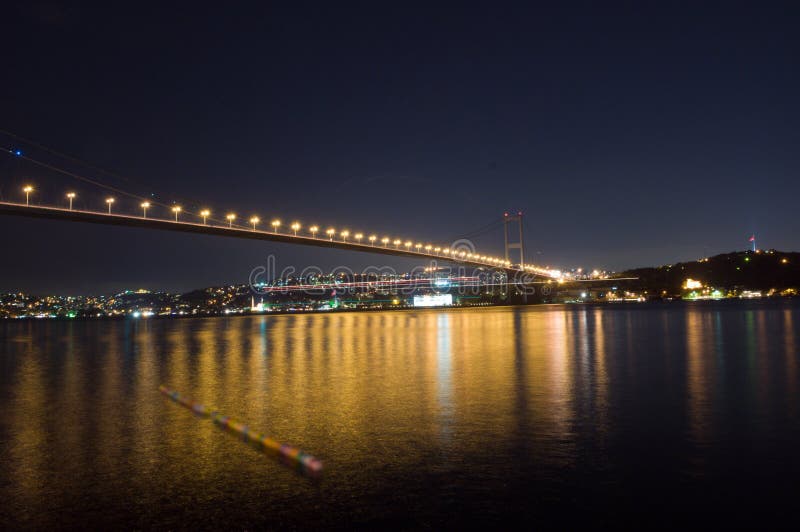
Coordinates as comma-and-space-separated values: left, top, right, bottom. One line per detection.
0, 307, 797, 512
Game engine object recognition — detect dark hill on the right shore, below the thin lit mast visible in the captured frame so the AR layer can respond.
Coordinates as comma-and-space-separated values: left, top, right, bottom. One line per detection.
620, 249, 800, 294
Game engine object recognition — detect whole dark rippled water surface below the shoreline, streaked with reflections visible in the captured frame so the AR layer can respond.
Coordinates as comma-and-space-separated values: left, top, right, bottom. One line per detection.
0, 302, 800, 528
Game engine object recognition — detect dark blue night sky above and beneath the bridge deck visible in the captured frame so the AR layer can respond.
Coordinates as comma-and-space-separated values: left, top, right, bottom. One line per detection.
0, 2, 800, 293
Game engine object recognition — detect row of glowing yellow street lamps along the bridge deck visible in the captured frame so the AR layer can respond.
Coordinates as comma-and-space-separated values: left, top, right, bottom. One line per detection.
22, 185, 511, 266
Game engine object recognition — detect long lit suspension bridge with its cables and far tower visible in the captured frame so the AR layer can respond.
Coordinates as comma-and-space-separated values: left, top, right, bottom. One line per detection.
0, 137, 561, 280
